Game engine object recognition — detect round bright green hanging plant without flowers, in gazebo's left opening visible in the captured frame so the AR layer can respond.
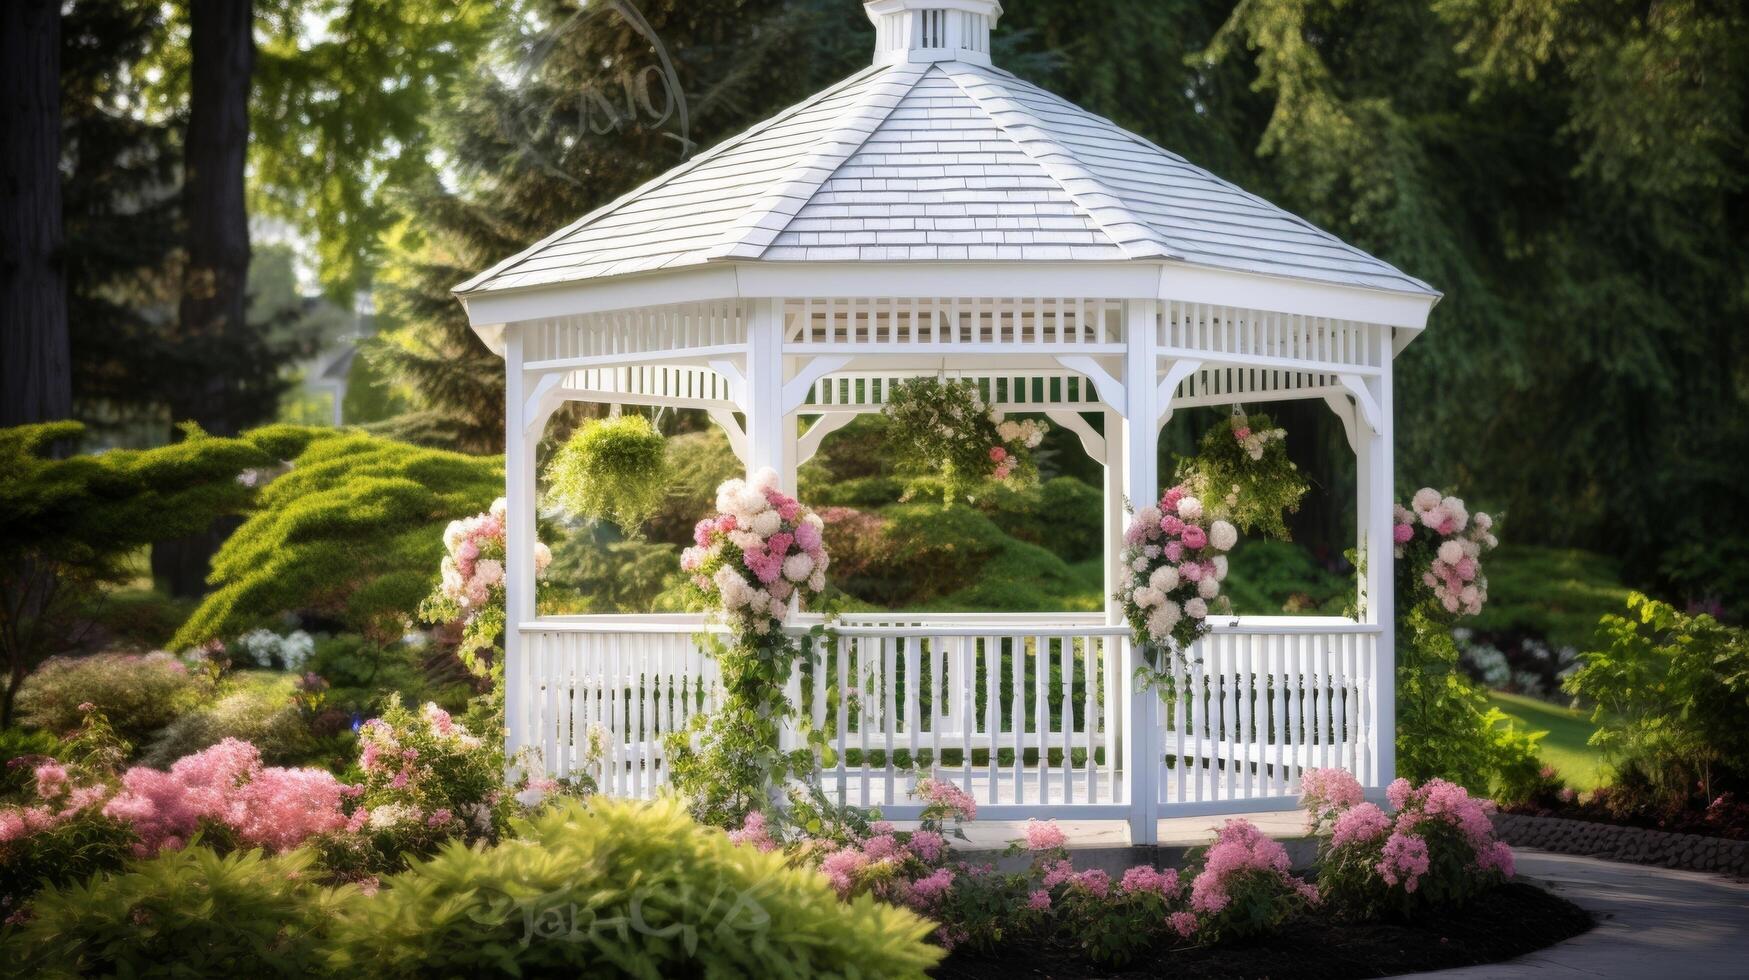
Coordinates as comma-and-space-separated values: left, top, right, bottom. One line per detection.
546, 415, 673, 536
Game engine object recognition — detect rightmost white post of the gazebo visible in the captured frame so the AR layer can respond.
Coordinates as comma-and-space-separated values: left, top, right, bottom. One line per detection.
1355, 327, 1397, 786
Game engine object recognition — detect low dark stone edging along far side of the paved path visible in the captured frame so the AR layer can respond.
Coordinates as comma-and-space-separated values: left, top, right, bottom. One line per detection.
1494, 814, 1749, 877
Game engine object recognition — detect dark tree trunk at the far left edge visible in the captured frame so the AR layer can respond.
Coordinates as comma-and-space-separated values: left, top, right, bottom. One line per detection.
0, 0, 73, 425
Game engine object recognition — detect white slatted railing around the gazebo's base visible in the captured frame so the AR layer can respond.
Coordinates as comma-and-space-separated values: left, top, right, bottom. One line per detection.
509, 613, 1380, 819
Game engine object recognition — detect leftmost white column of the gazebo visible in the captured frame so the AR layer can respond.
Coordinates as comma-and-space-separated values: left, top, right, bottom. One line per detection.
504, 324, 540, 758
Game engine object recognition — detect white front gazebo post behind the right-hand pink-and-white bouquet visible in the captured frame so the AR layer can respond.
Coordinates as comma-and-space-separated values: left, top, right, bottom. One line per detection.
1123, 299, 1160, 844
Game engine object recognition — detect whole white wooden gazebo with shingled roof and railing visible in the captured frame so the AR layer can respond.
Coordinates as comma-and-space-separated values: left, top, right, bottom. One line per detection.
456, 0, 1439, 842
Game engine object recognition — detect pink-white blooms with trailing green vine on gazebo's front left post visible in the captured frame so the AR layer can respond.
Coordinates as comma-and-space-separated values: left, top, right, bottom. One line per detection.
668, 469, 831, 828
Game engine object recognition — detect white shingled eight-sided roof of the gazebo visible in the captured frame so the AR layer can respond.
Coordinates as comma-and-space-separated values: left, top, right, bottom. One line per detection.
456, 0, 1438, 296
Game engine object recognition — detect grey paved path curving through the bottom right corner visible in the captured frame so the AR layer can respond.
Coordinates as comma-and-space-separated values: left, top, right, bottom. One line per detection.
1417, 849, 1749, 980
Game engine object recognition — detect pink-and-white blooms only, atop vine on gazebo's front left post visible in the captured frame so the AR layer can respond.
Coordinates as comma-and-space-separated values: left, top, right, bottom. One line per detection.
680, 469, 831, 635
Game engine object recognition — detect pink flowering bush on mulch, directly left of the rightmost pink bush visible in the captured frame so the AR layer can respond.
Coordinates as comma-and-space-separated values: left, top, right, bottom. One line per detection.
1184, 821, 1319, 942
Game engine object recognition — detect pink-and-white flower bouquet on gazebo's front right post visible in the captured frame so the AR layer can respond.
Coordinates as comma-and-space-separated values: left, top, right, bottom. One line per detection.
1116, 485, 1238, 672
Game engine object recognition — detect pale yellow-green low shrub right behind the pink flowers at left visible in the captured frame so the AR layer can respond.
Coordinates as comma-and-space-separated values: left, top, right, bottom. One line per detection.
142, 670, 315, 768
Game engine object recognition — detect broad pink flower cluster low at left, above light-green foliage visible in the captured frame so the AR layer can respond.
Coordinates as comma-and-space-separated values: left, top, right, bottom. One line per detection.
103, 739, 352, 854
